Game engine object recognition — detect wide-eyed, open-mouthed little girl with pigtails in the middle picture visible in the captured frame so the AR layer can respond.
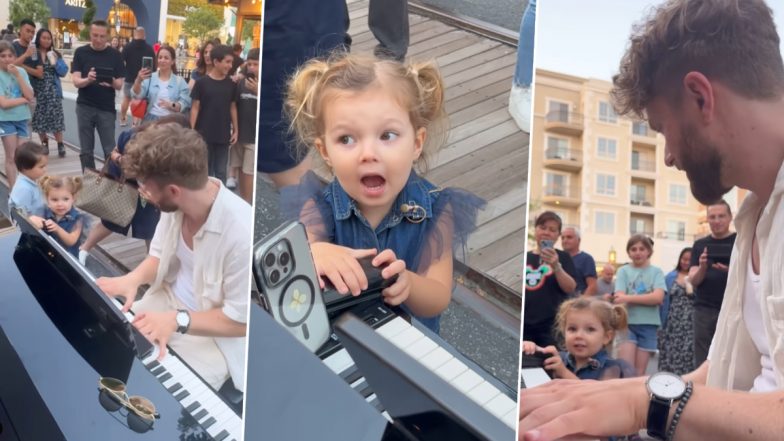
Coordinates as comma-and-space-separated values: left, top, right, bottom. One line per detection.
281, 54, 483, 332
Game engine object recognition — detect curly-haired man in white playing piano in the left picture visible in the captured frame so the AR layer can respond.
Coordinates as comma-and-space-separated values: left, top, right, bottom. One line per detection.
97, 124, 251, 390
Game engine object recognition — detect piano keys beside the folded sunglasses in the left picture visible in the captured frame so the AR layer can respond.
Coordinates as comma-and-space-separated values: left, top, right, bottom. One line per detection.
112, 299, 243, 441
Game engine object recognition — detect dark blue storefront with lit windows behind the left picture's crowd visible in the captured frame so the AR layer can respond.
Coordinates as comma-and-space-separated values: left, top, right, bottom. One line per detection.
46, 0, 163, 48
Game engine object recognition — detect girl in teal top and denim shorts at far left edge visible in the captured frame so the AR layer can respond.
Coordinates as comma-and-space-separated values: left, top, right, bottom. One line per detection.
0, 40, 33, 188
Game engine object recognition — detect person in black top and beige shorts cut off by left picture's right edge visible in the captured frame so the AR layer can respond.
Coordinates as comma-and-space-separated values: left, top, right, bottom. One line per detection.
227, 48, 259, 204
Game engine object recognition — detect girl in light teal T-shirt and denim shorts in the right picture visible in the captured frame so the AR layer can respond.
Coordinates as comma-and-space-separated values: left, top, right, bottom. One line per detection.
607, 234, 667, 375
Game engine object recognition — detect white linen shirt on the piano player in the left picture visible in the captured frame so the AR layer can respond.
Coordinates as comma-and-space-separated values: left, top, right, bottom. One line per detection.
149, 178, 252, 392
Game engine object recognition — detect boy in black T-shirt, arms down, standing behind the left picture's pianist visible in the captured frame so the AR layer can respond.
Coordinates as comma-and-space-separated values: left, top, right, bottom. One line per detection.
191, 44, 238, 184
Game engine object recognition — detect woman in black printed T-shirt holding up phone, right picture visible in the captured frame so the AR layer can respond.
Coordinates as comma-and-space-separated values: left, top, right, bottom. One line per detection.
523, 211, 577, 347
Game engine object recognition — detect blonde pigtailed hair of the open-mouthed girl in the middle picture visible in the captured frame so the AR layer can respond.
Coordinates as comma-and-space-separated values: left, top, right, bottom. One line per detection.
284, 52, 447, 173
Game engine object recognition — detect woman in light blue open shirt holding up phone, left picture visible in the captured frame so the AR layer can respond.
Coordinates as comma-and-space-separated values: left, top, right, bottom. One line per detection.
131, 46, 191, 121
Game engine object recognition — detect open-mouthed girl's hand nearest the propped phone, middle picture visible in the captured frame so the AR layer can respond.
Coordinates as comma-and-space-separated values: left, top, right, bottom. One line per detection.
310, 242, 376, 296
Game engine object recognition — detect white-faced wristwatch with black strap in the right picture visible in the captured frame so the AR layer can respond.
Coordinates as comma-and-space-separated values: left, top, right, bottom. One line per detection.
645, 372, 686, 440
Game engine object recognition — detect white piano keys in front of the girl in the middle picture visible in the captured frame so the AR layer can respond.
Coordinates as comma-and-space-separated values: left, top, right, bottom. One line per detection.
323, 317, 518, 429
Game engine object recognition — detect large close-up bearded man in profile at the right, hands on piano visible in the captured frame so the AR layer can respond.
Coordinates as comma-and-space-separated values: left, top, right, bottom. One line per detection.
519, 0, 784, 441
